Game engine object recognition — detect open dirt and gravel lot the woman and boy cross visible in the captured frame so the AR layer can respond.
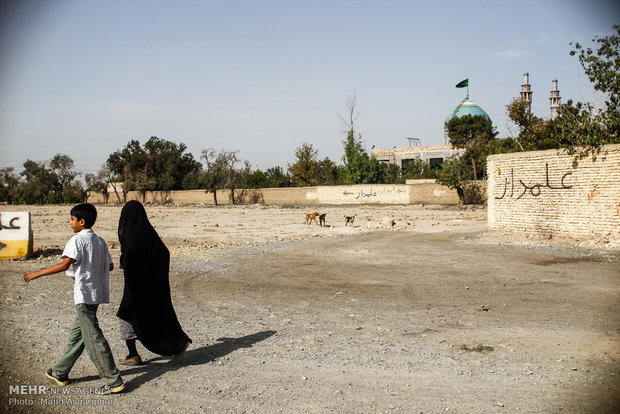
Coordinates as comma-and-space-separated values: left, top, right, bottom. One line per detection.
0, 206, 620, 413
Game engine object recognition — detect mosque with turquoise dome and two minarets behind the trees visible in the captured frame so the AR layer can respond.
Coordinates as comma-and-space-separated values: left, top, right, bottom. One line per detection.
370, 73, 561, 168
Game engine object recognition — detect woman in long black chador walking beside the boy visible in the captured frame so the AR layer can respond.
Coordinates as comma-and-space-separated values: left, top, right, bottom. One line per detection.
116, 201, 192, 365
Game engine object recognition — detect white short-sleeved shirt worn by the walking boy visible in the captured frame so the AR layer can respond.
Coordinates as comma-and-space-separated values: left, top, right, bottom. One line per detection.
62, 229, 112, 305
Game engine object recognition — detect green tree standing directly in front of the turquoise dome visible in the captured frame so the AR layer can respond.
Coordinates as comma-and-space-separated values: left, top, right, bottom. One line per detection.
447, 115, 497, 180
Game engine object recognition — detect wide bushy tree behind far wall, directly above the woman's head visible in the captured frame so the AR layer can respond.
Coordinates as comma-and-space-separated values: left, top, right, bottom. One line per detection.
107, 137, 201, 194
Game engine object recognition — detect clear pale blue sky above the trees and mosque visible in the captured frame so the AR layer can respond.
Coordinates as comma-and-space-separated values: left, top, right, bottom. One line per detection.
0, 0, 620, 173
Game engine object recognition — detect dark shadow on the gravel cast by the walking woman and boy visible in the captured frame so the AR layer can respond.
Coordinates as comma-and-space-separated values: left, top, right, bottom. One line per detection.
77, 331, 276, 392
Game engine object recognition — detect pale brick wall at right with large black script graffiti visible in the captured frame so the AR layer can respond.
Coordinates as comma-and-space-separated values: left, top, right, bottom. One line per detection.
487, 145, 620, 242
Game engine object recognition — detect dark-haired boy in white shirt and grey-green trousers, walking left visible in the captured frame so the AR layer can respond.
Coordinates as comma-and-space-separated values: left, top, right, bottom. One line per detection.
24, 203, 125, 394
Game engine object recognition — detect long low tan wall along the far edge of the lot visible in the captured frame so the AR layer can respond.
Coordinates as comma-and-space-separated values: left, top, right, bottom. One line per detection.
88, 183, 459, 205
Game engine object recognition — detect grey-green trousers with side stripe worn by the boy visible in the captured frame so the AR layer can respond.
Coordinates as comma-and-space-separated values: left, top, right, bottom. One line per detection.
52, 303, 123, 388
